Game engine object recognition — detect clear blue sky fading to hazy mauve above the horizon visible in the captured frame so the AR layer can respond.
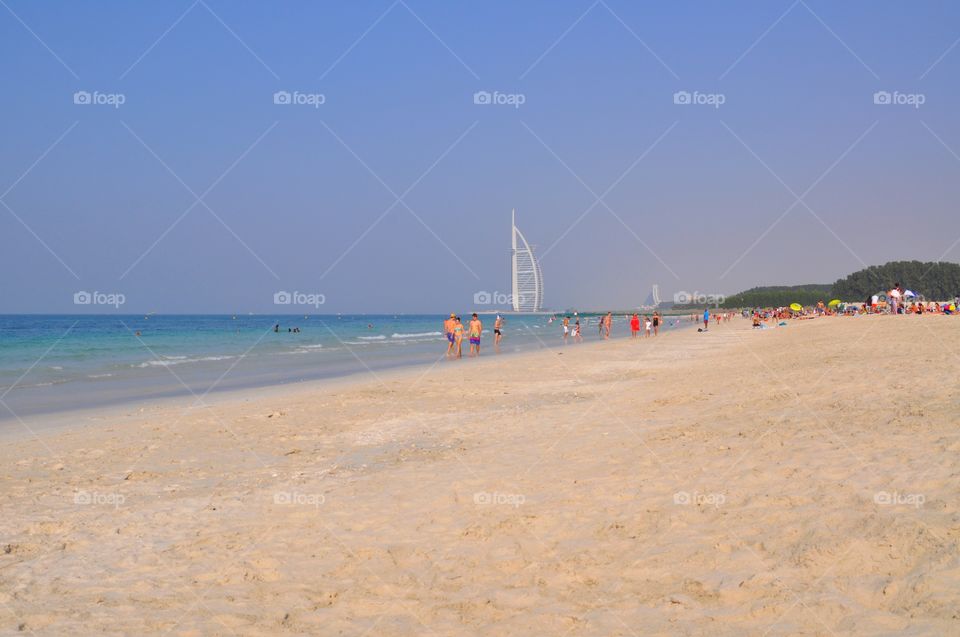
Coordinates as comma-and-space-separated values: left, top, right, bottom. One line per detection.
0, 0, 960, 313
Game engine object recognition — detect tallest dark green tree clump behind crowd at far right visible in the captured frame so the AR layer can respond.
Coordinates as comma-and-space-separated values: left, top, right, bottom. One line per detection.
832, 261, 960, 301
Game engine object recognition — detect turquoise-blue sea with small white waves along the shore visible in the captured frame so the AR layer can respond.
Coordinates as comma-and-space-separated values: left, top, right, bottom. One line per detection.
0, 313, 689, 427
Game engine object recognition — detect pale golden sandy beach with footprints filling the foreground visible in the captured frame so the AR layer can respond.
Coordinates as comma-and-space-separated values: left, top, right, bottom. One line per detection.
0, 316, 960, 636
